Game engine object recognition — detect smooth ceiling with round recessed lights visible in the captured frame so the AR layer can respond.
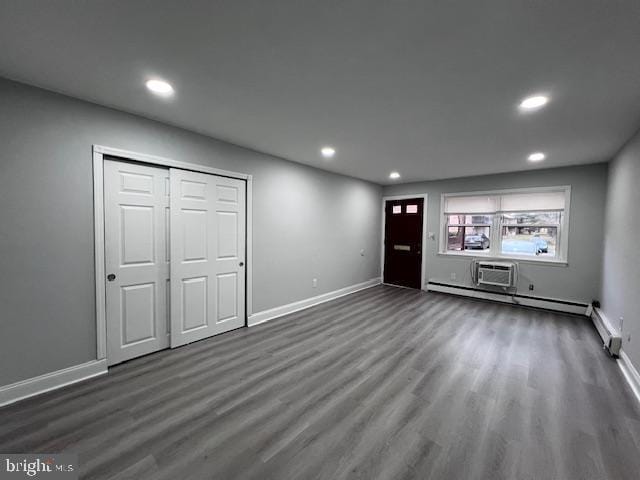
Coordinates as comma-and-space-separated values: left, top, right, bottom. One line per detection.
0, 0, 640, 184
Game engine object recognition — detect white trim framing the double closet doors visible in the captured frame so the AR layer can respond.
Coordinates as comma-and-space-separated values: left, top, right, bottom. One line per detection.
93, 145, 253, 360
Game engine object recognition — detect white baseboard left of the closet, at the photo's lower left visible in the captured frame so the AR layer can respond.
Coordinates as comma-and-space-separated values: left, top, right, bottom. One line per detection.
0, 359, 107, 407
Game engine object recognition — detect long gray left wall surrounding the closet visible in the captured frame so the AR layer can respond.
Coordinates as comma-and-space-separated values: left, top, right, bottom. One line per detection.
0, 79, 381, 385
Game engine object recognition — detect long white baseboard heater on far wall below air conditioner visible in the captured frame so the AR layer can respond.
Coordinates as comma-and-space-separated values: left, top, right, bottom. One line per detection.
427, 282, 589, 315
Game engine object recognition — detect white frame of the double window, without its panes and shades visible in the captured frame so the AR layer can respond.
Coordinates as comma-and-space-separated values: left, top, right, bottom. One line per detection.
438, 185, 571, 265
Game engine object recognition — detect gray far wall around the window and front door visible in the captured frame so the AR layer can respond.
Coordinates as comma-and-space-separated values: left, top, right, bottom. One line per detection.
383, 164, 607, 302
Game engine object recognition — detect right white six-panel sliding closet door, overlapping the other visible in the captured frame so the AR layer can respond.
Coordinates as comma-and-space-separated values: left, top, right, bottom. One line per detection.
170, 168, 246, 347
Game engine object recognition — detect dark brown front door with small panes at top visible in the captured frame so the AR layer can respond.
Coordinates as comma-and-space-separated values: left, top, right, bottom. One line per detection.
384, 198, 424, 288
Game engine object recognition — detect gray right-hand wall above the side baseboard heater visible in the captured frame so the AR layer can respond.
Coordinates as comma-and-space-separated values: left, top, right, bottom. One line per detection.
602, 127, 640, 368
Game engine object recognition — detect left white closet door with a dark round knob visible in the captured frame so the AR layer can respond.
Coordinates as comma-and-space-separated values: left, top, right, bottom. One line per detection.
104, 160, 169, 365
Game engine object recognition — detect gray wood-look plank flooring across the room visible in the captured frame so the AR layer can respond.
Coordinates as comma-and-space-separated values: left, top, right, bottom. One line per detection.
0, 286, 640, 480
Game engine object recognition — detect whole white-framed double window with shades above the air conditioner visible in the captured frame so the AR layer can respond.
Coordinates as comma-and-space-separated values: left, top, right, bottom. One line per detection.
441, 187, 570, 261
